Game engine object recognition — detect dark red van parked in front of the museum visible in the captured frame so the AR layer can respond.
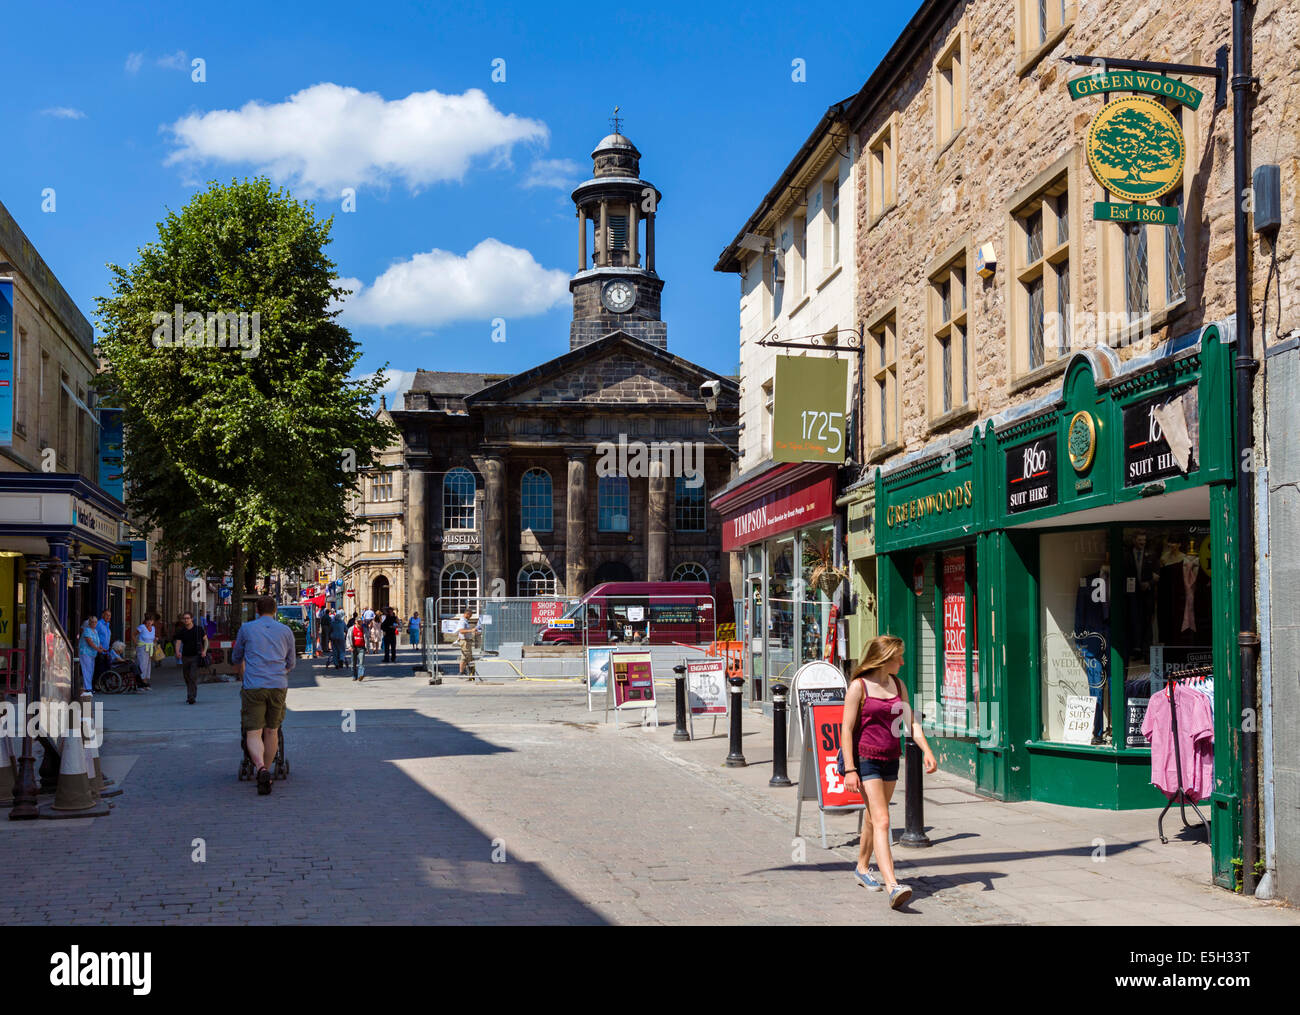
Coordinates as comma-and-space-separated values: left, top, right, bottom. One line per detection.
533, 581, 736, 645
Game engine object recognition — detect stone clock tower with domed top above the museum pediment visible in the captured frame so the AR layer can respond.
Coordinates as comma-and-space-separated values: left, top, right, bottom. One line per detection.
569, 116, 668, 350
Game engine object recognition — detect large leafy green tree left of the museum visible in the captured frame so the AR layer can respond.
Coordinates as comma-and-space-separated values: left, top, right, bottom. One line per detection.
96, 178, 393, 623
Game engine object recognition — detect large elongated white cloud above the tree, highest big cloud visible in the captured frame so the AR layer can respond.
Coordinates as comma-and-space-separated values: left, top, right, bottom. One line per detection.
166, 83, 550, 196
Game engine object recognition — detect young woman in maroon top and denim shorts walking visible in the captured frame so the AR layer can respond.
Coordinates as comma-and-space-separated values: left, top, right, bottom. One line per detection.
840, 634, 939, 910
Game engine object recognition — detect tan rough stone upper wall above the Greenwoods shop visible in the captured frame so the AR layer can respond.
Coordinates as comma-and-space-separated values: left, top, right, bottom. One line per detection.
857, 0, 1300, 454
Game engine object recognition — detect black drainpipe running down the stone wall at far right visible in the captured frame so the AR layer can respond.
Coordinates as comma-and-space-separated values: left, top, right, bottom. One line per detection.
1232, 0, 1260, 895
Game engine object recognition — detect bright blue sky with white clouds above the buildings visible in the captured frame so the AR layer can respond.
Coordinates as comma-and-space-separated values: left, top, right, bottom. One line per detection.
0, 0, 915, 402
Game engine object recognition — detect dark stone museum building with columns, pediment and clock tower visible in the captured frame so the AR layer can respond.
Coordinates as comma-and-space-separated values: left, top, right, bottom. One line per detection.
379, 133, 738, 615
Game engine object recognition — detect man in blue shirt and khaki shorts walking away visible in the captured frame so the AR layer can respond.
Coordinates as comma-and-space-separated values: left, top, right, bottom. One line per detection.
230, 595, 298, 797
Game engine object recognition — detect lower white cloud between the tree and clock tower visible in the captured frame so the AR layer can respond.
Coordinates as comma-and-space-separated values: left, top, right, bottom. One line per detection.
339, 238, 569, 328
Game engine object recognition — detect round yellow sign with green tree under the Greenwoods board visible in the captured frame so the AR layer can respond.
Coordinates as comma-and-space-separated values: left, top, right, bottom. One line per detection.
1088, 95, 1187, 201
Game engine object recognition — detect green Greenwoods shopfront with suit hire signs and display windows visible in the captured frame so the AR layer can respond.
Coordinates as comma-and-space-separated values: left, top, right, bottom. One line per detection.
875, 325, 1240, 886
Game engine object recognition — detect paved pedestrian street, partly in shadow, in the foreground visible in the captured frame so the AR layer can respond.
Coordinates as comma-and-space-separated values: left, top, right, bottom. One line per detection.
0, 651, 1300, 924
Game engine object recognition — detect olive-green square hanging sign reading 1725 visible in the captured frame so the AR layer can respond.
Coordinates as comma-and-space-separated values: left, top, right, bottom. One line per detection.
772, 356, 849, 465
